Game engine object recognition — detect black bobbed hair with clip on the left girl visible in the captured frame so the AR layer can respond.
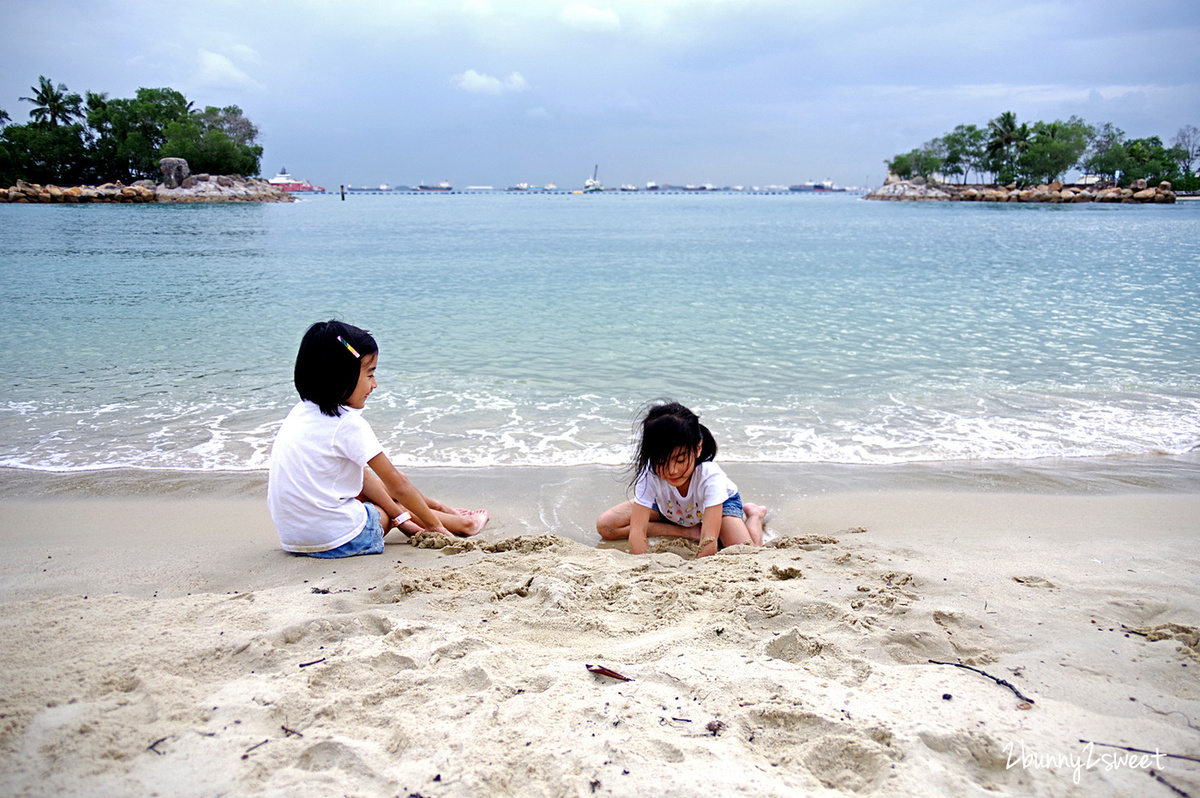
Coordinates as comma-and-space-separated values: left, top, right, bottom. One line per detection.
293, 319, 379, 416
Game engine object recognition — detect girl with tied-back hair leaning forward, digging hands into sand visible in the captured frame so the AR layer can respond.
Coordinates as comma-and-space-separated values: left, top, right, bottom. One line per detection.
596, 401, 767, 557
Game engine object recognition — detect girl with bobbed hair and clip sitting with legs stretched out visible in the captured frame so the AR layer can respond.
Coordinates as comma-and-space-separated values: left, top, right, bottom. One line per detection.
266, 320, 487, 557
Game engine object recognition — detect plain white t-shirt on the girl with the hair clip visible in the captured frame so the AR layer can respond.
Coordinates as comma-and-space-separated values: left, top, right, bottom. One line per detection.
266, 401, 383, 552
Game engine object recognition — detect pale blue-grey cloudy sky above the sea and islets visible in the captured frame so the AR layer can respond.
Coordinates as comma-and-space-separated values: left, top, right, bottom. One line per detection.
0, 0, 1200, 188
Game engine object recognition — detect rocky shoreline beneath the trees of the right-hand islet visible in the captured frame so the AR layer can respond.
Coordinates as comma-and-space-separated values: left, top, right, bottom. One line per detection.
864, 180, 1176, 204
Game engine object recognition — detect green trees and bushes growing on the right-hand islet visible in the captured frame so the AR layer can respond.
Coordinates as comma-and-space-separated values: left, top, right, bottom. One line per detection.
884, 110, 1200, 191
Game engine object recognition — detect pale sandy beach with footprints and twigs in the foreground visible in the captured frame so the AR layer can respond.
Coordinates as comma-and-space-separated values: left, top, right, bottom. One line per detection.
0, 463, 1200, 798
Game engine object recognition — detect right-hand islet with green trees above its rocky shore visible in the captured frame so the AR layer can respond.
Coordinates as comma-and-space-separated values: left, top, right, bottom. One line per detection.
866, 112, 1200, 203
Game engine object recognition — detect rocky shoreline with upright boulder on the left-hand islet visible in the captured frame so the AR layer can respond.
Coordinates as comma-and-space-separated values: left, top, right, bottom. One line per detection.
0, 158, 295, 203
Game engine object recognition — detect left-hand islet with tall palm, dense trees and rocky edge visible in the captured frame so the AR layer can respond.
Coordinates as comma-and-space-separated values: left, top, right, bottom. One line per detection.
0, 76, 293, 203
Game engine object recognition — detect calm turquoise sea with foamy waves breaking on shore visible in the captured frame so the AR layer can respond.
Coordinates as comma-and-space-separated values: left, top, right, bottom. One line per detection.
0, 193, 1200, 470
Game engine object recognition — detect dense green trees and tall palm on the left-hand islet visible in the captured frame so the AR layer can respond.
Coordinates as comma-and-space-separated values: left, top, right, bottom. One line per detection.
0, 76, 263, 186
